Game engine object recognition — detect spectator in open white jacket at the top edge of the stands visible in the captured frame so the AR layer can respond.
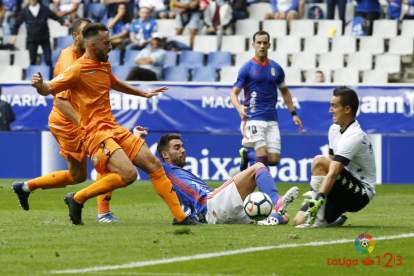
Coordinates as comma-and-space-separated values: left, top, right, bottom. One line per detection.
203, 0, 233, 49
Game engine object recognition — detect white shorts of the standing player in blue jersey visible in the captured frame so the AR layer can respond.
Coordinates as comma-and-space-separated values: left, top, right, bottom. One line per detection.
240, 120, 281, 154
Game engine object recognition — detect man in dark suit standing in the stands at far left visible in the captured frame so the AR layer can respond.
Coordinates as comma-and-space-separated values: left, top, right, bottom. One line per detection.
12, 0, 72, 66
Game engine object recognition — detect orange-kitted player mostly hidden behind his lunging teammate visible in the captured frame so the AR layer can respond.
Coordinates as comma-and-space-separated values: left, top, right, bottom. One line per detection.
13, 18, 121, 222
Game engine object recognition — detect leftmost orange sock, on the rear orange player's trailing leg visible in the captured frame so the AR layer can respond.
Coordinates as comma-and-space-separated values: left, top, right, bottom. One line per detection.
27, 171, 76, 191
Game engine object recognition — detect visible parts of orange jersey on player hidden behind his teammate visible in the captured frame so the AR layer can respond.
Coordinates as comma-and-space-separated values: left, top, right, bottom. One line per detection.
49, 46, 81, 126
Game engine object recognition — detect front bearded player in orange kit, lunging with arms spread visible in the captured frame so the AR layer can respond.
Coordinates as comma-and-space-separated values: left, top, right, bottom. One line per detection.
31, 23, 198, 225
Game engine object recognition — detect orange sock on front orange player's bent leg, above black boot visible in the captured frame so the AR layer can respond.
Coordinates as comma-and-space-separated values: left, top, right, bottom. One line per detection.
73, 173, 126, 204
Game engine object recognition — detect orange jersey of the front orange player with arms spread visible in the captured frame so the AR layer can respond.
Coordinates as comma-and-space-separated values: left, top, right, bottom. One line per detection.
49, 56, 119, 138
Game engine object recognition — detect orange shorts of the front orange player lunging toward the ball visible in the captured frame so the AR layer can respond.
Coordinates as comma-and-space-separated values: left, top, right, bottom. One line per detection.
84, 126, 145, 174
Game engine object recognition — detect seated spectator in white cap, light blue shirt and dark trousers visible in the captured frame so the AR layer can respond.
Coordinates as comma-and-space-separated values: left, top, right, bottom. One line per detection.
127, 33, 166, 81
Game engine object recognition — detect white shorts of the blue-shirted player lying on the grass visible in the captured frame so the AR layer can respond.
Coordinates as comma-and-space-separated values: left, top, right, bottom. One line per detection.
206, 178, 253, 224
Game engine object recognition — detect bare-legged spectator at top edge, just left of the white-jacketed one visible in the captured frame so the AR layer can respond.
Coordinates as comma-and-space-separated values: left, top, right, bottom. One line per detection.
174, 0, 200, 48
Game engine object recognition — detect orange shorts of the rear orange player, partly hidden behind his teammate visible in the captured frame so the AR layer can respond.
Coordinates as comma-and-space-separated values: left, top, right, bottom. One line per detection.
49, 107, 86, 162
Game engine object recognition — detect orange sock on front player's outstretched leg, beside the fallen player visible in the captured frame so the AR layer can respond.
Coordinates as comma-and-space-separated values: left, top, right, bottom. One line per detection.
148, 167, 186, 221
